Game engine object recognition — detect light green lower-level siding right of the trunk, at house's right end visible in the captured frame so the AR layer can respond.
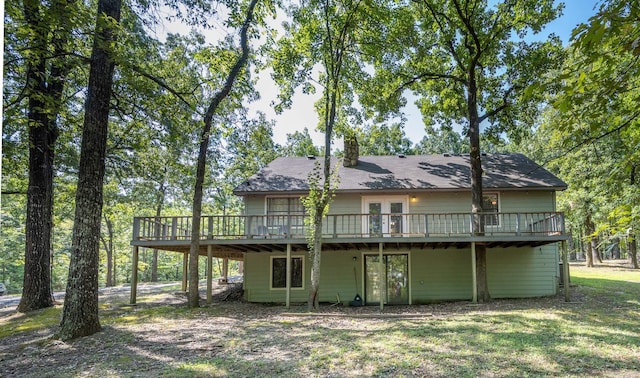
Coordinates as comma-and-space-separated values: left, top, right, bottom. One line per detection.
487, 244, 559, 298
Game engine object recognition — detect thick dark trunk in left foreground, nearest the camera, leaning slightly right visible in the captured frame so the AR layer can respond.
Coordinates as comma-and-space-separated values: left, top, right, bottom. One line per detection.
58, 0, 122, 340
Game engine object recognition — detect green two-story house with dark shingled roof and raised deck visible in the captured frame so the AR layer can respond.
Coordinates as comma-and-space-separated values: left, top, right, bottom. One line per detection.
132, 150, 567, 307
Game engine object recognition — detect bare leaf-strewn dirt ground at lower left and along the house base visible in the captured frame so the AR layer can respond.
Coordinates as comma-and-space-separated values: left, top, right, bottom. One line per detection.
0, 267, 640, 377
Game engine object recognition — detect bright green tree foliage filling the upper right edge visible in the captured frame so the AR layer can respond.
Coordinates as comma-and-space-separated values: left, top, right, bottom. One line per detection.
550, 0, 640, 268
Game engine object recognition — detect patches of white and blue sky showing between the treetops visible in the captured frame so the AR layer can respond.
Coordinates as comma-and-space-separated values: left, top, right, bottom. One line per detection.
251, 0, 599, 149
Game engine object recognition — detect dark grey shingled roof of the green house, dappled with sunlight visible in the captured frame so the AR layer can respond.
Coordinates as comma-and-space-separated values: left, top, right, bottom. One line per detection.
234, 154, 567, 196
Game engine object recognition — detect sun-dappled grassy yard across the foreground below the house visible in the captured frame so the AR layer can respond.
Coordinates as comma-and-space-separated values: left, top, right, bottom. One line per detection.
0, 265, 640, 377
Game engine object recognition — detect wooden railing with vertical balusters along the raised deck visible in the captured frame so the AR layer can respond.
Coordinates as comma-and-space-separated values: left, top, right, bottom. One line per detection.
133, 212, 565, 241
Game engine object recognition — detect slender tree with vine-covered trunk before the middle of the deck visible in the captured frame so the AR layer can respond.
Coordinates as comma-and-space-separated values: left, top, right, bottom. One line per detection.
272, 0, 373, 310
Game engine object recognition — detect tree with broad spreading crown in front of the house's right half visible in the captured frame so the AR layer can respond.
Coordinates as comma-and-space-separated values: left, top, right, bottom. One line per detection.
363, 0, 561, 301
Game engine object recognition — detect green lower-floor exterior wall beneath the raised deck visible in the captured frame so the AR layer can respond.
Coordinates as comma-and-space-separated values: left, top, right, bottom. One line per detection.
244, 244, 559, 304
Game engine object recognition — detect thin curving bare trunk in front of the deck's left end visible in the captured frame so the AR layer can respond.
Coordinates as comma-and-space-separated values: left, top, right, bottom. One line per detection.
187, 0, 258, 307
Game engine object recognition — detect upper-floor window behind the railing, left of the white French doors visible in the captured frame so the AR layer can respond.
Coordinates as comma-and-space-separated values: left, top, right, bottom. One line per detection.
267, 197, 304, 235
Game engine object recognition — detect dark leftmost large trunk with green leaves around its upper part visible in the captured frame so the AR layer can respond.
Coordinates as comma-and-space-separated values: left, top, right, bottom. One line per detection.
18, 0, 73, 312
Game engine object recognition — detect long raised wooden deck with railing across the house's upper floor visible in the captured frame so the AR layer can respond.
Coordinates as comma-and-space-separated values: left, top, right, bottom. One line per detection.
131, 212, 567, 259
